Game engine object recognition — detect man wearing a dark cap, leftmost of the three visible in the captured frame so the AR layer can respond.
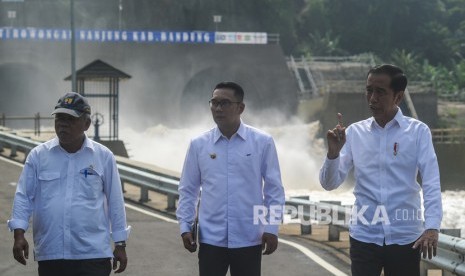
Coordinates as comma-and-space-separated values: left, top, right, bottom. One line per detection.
8, 92, 130, 276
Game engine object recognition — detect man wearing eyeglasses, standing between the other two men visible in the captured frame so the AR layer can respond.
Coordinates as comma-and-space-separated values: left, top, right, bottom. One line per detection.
176, 82, 284, 276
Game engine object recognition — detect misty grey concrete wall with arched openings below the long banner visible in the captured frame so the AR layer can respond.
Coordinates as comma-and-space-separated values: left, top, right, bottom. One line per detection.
0, 40, 298, 129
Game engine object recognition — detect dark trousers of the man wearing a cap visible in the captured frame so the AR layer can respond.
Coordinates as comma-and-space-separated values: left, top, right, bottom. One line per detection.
38, 258, 111, 276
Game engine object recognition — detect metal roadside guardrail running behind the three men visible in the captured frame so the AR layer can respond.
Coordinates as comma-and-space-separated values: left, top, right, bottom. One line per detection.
0, 131, 465, 275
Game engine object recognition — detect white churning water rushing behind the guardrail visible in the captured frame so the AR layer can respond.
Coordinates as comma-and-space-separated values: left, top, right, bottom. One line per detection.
120, 120, 465, 235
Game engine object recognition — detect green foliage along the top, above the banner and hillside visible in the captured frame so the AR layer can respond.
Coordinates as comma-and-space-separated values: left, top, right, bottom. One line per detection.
0, 0, 465, 97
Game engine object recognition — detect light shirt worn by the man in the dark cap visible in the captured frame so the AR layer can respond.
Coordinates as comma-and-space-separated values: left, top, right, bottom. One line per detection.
8, 137, 129, 261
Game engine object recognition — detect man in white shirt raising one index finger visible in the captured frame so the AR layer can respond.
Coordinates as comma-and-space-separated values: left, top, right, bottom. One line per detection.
320, 64, 442, 276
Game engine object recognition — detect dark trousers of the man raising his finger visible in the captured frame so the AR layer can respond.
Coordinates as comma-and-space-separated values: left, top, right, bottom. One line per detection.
350, 237, 420, 276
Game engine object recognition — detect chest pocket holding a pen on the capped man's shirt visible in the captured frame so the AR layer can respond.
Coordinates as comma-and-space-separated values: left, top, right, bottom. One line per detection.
78, 169, 103, 199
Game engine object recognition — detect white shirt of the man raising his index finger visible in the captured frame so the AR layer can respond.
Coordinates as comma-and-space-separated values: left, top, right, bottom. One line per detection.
320, 108, 442, 245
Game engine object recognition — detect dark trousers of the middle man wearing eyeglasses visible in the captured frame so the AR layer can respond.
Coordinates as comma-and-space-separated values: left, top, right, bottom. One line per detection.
199, 243, 262, 276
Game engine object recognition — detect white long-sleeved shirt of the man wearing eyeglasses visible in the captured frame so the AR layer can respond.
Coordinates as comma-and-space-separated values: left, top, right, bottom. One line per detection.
176, 123, 284, 248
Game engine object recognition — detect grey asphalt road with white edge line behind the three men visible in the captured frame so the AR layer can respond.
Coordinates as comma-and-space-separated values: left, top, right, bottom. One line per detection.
0, 157, 350, 276
